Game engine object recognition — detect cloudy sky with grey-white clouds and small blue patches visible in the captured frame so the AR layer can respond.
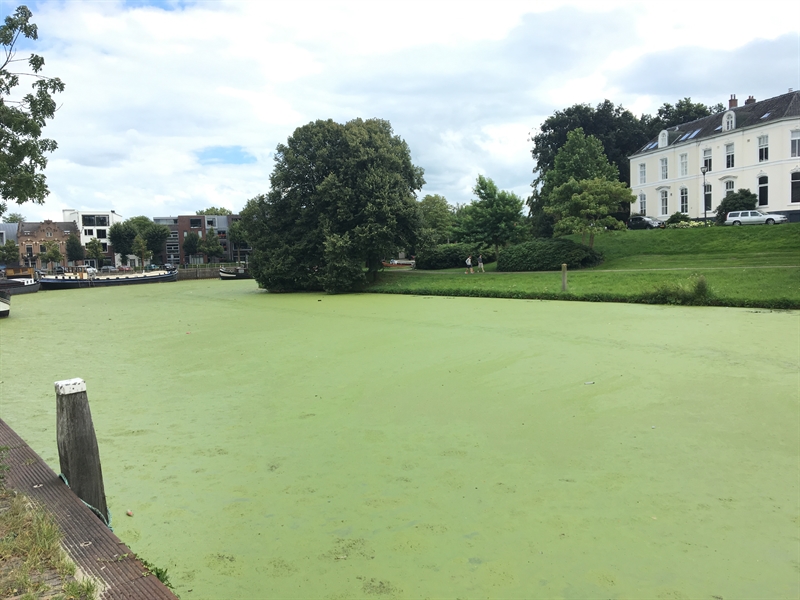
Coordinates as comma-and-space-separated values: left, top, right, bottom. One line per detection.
6, 0, 800, 221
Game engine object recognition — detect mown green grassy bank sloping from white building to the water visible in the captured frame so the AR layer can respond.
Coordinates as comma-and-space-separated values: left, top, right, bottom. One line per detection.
368, 224, 800, 309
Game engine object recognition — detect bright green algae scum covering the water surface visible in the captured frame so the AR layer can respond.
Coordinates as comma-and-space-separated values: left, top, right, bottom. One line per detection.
0, 280, 800, 600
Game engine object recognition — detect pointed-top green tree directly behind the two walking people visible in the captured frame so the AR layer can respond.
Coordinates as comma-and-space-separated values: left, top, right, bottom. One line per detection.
461, 175, 523, 256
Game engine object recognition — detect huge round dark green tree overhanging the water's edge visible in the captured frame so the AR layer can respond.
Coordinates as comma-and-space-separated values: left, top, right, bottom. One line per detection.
242, 119, 424, 293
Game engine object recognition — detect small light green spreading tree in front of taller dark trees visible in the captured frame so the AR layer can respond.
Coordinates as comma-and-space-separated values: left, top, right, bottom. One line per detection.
545, 177, 635, 248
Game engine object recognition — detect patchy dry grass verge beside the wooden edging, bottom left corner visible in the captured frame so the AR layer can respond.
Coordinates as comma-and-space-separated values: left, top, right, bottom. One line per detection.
0, 448, 97, 600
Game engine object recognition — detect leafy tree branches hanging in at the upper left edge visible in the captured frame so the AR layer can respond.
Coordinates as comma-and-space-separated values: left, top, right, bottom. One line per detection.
0, 6, 64, 220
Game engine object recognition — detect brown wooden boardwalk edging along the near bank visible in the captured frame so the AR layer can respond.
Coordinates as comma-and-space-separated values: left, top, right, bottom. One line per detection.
0, 419, 176, 600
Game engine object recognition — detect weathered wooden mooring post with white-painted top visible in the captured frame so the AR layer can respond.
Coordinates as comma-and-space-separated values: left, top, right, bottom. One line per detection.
55, 379, 109, 525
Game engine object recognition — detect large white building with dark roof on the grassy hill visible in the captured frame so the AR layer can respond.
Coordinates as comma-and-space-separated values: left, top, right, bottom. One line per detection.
630, 91, 800, 221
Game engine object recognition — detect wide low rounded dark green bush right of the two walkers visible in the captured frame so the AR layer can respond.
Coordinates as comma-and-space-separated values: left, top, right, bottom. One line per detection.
497, 238, 603, 271
